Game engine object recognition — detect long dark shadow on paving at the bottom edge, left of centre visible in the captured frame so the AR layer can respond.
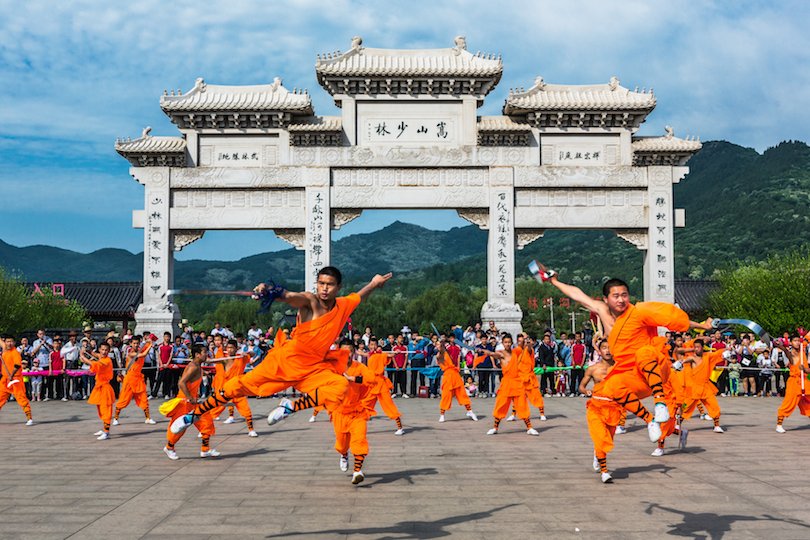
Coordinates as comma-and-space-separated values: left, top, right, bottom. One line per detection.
266, 504, 517, 540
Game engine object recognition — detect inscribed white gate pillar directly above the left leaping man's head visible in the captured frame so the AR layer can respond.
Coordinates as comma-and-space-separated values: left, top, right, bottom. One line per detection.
302, 168, 332, 292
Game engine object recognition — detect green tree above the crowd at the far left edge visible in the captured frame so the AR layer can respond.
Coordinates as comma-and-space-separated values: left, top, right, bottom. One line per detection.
0, 269, 87, 335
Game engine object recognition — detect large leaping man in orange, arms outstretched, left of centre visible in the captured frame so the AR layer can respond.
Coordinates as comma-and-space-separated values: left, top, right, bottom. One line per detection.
171, 266, 392, 433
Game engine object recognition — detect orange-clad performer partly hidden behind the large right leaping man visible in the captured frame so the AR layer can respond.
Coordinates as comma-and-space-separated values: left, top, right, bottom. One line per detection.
578, 339, 624, 484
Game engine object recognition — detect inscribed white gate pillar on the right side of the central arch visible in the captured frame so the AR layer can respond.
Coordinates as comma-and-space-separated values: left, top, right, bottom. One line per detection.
481, 167, 523, 335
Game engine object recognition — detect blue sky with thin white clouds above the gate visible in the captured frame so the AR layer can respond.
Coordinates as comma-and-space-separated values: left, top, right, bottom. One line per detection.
0, 0, 810, 259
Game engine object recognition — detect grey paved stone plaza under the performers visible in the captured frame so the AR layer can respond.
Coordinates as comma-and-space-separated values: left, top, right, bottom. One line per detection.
0, 398, 810, 540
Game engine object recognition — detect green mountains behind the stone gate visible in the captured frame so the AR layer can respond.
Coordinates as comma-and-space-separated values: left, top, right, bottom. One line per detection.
0, 137, 810, 297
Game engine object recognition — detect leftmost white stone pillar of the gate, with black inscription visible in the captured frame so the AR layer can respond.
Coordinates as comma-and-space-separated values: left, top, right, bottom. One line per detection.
130, 167, 180, 335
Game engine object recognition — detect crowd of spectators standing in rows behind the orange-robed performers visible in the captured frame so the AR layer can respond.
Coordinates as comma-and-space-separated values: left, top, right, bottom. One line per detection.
11, 321, 800, 401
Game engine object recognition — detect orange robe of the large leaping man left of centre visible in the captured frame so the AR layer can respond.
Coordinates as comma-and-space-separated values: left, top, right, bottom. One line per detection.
218, 293, 360, 412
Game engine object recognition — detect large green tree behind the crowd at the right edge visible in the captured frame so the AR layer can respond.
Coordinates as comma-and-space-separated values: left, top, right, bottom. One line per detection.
709, 246, 810, 333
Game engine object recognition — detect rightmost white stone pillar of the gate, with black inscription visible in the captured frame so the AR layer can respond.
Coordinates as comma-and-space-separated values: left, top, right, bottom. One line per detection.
644, 166, 675, 302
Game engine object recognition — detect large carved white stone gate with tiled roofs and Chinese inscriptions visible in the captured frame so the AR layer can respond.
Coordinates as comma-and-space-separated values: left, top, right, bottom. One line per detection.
115, 37, 700, 332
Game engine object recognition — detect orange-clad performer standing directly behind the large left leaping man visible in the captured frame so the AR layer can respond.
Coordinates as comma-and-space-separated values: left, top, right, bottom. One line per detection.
332, 339, 377, 484
